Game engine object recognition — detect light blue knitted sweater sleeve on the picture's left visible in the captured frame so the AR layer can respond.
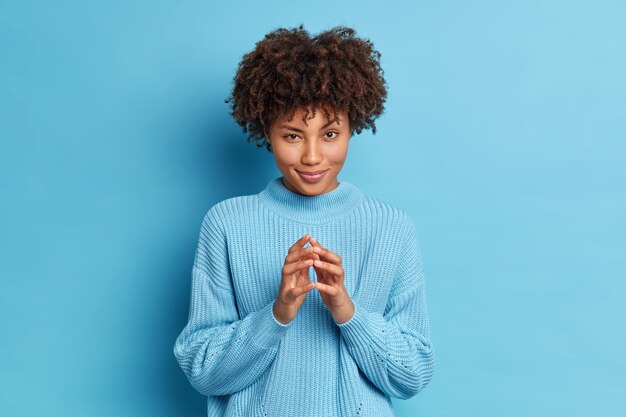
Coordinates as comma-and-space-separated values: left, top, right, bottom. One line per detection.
174, 209, 291, 396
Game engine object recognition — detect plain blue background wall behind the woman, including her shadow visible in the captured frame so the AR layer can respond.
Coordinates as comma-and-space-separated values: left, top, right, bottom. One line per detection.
0, 0, 626, 417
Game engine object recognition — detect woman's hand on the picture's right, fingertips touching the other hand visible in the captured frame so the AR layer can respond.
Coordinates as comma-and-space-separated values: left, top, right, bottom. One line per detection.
310, 237, 354, 323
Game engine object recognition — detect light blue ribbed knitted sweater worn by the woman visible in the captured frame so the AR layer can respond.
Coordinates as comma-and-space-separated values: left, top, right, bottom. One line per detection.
174, 177, 434, 417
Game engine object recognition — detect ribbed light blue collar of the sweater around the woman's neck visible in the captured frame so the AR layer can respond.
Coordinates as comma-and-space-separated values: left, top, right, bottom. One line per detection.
259, 176, 363, 224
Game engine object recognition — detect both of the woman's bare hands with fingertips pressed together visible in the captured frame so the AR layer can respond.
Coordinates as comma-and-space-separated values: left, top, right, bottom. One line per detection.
273, 234, 354, 324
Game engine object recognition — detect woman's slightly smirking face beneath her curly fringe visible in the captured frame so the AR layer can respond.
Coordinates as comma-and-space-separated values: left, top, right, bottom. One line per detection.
266, 104, 351, 196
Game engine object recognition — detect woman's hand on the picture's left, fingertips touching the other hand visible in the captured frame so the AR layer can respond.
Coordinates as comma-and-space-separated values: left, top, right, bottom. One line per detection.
272, 234, 313, 324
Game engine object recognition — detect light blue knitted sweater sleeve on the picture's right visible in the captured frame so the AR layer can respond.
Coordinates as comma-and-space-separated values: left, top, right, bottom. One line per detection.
337, 218, 435, 399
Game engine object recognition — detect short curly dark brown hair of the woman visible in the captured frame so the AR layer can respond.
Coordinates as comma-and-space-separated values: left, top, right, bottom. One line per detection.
225, 24, 387, 152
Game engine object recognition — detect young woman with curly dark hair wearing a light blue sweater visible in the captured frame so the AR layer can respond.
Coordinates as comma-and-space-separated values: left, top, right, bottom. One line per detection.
174, 26, 434, 417
